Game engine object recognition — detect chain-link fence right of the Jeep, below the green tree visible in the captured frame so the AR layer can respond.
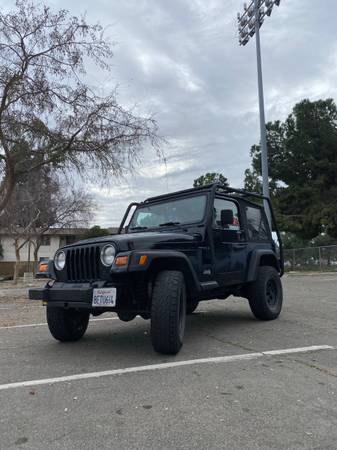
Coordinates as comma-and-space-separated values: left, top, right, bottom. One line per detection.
284, 245, 337, 272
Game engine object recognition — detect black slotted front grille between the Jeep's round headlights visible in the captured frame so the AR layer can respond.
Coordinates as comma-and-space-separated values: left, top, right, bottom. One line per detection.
66, 246, 100, 281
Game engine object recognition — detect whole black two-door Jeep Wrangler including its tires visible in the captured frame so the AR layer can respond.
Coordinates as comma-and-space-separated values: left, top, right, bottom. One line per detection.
29, 184, 283, 354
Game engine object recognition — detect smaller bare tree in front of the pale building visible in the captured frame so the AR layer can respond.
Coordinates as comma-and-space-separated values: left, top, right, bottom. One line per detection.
0, 167, 92, 283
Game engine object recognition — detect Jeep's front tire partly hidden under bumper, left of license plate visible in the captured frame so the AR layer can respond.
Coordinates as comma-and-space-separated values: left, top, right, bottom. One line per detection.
47, 306, 89, 342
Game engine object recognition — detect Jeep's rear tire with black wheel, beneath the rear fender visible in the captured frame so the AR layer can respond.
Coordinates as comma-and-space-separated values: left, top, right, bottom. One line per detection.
248, 266, 283, 320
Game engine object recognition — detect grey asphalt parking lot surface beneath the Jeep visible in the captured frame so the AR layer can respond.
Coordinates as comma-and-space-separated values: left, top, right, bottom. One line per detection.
0, 274, 337, 450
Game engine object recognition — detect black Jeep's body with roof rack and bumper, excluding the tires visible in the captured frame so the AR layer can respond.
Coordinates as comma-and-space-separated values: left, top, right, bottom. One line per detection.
29, 184, 283, 353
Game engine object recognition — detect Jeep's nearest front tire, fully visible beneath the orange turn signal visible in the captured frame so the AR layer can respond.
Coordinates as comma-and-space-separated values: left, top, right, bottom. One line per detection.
151, 270, 186, 355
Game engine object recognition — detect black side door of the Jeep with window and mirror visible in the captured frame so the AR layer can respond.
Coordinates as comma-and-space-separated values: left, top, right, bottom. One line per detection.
213, 197, 247, 286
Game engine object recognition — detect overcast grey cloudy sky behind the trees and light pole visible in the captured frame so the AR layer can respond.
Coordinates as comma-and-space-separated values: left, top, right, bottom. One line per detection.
7, 0, 337, 226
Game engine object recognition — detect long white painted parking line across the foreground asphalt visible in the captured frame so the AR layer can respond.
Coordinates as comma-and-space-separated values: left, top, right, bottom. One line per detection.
0, 345, 335, 391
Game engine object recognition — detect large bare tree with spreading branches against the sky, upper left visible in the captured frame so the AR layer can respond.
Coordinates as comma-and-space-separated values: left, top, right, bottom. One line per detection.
0, 0, 159, 212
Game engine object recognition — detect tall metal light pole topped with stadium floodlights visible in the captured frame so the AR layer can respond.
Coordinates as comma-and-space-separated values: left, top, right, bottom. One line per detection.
238, 0, 281, 224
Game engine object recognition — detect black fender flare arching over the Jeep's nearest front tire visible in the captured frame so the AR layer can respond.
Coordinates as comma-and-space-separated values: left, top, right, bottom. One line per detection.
128, 250, 201, 295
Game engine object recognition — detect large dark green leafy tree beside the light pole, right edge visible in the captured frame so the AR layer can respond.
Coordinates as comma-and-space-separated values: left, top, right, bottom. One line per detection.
245, 99, 337, 239
